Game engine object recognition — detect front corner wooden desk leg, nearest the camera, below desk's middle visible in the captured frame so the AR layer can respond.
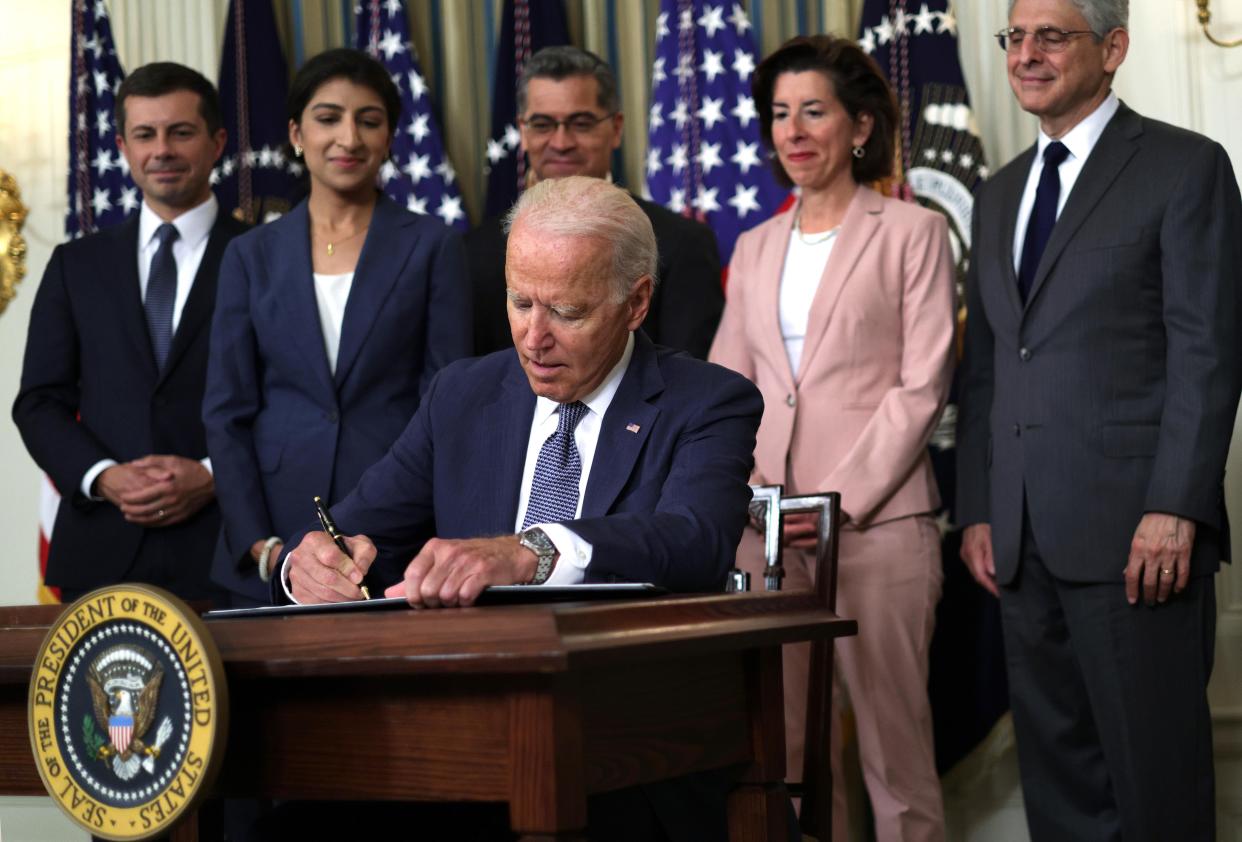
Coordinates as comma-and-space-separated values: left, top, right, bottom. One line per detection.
509, 678, 586, 841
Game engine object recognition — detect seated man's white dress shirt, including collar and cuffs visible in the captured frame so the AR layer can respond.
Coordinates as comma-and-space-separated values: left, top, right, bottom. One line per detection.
281, 333, 633, 602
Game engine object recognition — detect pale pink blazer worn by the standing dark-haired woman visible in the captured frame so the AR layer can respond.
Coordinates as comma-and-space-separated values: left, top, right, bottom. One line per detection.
710, 188, 954, 527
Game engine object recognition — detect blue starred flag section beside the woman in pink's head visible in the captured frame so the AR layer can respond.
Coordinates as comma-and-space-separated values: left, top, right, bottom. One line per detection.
647, 0, 787, 265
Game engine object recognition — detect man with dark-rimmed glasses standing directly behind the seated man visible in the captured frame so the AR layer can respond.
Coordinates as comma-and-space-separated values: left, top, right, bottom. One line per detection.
466, 46, 724, 359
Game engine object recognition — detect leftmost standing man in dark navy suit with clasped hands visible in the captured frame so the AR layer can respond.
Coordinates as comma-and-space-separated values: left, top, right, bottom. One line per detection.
12, 62, 245, 599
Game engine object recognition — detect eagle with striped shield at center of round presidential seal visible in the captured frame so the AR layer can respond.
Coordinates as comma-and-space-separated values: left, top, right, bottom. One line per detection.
86, 645, 173, 781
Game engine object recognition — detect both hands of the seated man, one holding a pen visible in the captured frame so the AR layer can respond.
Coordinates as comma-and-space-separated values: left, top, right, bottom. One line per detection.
286, 532, 537, 609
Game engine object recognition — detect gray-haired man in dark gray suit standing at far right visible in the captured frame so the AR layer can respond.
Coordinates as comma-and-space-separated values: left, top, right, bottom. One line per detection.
958, 0, 1242, 842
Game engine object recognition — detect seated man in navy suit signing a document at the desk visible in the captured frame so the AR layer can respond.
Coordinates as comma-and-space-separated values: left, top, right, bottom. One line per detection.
272, 176, 763, 841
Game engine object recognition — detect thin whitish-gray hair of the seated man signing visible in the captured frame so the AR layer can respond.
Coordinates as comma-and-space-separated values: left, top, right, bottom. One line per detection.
504, 175, 660, 302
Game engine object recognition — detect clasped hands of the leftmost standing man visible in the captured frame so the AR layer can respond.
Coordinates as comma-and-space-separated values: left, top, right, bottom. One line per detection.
94, 456, 216, 527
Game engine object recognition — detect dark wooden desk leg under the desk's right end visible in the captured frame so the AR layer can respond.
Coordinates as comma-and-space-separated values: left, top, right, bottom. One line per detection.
729, 646, 789, 842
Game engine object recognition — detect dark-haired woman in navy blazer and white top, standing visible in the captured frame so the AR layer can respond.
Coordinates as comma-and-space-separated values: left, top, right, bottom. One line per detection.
202, 50, 472, 606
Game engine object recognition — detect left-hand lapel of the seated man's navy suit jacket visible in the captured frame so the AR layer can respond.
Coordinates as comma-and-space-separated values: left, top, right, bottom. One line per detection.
469, 360, 535, 535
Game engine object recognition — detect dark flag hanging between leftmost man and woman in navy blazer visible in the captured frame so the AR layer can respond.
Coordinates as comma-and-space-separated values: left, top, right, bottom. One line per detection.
211, 0, 303, 224
